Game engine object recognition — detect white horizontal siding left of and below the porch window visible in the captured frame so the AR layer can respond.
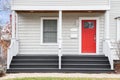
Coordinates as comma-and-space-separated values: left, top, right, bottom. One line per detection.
18, 13, 58, 54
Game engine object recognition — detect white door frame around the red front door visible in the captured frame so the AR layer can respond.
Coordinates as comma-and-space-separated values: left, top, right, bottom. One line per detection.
79, 17, 99, 55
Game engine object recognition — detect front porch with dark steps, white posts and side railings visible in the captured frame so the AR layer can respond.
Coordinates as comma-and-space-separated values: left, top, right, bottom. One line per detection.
7, 10, 113, 72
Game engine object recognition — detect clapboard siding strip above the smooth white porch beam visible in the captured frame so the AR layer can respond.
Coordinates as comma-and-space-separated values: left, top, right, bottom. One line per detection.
12, 0, 109, 6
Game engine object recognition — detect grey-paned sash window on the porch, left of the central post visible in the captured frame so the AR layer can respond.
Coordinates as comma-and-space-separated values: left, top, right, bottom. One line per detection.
42, 18, 57, 43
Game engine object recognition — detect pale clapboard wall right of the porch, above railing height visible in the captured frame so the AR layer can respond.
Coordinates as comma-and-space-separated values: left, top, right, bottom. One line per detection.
110, 0, 120, 40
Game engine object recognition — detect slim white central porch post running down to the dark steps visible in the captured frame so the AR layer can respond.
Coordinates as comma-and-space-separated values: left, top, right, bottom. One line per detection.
58, 10, 62, 69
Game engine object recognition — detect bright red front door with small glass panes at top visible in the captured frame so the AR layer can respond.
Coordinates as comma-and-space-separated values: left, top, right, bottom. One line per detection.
81, 20, 96, 54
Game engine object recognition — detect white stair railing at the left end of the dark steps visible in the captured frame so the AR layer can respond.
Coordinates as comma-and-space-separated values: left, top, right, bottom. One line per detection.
7, 39, 19, 69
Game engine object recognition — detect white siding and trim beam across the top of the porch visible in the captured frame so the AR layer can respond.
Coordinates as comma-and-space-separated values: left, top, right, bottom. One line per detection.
11, 0, 110, 10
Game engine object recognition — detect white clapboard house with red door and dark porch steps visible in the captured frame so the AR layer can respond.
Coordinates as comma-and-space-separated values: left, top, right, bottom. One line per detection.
7, 0, 120, 72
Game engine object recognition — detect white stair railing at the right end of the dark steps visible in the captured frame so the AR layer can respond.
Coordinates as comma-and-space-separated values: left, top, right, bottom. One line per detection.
103, 40, 114, 70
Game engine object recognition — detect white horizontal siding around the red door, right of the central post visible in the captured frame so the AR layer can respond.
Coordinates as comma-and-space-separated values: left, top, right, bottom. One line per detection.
62, 13, 104, 54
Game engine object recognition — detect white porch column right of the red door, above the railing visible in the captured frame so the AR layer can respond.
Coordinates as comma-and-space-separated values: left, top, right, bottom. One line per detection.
104, 10, 110, 40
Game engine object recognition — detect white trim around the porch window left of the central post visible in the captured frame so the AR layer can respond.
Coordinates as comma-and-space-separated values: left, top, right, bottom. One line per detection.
40, 17, 58, 45
